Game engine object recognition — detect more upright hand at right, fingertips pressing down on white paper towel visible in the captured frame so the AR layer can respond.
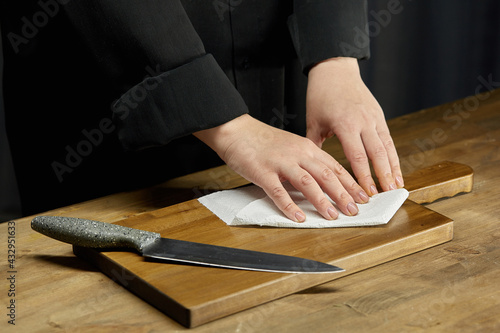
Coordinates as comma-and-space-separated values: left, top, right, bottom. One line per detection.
306, 58, 404, 196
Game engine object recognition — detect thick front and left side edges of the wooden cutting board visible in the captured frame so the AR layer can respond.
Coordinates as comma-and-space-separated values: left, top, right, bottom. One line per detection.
73, 218, 453, 328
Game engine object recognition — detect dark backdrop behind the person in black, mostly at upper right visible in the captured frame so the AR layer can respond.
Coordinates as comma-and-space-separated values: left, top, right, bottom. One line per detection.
0, 0, 500, 221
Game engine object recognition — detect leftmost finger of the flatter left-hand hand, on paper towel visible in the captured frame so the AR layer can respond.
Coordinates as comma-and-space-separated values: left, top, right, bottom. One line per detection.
260, 177, 306, 222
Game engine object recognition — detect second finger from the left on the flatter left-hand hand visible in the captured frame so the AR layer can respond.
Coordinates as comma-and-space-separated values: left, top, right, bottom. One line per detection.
286, 166, 340, 220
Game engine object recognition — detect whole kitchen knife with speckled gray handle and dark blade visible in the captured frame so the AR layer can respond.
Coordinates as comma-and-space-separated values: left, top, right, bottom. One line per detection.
31, 216, 344, 273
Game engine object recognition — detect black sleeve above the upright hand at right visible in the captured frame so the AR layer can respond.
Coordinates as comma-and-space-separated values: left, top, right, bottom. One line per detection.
288, 0, 370, 73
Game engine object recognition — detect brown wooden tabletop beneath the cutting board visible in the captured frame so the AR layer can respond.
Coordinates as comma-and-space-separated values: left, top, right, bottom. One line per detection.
0, 90, 500, 333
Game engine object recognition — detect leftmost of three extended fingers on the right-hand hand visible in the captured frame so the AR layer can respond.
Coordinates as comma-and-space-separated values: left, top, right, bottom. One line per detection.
337, 134, 378, 196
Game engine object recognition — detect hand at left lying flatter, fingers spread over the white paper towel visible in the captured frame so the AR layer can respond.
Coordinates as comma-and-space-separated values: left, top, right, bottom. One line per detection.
194, 115, 369, 222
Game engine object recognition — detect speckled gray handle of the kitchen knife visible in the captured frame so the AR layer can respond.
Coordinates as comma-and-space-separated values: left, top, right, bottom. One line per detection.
31, 216, 160, 253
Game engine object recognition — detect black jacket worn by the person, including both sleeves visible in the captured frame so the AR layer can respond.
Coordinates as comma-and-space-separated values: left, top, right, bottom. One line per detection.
0, 0, 369, 213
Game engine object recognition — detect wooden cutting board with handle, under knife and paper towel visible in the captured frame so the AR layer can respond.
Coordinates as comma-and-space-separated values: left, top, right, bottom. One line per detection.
74, 162, 473, 327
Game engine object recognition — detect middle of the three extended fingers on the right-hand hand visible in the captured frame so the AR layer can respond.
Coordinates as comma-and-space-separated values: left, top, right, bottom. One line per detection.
362, 128, 397, 191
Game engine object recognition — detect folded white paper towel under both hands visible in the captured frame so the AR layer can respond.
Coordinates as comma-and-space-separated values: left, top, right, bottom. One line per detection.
198, 184, 408, 228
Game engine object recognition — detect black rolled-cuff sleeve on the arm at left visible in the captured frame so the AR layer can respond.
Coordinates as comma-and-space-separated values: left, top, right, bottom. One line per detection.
65, 0, 248, 150
